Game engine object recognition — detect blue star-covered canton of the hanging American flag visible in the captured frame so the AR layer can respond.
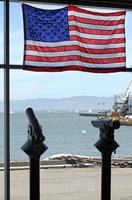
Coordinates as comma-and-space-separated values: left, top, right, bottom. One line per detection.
24, 5, 69, 42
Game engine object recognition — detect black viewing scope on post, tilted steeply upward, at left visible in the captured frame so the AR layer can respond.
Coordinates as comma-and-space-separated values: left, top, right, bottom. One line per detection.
21, 108, 48, 200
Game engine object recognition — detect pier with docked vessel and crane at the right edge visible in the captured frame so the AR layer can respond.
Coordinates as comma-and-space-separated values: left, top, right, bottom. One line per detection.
79, 80, 132, 126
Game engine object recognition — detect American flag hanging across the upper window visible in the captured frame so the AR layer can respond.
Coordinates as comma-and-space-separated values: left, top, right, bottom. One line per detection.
22, 4, 126, 73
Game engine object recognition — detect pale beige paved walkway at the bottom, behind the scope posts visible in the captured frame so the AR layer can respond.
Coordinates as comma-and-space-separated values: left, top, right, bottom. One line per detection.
0, 168, 132, 200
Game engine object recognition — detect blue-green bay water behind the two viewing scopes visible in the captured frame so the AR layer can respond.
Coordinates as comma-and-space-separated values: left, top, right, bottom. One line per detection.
0, 112, 132, 161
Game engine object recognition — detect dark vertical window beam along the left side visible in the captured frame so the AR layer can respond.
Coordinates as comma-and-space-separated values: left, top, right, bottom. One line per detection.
4, 0, 10, 200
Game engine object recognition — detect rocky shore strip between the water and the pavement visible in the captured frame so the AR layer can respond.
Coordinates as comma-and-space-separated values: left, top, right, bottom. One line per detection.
0, 154, 132, 170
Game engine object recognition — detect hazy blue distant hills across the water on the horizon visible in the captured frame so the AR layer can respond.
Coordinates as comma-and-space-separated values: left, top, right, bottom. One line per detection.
0, 96, 113, 112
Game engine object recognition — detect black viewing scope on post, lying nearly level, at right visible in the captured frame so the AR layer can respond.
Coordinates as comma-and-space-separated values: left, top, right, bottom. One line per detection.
91, 120, 120, 200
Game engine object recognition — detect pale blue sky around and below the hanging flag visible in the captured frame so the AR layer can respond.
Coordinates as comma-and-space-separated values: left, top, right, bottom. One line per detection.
0, 2, 132, 101
